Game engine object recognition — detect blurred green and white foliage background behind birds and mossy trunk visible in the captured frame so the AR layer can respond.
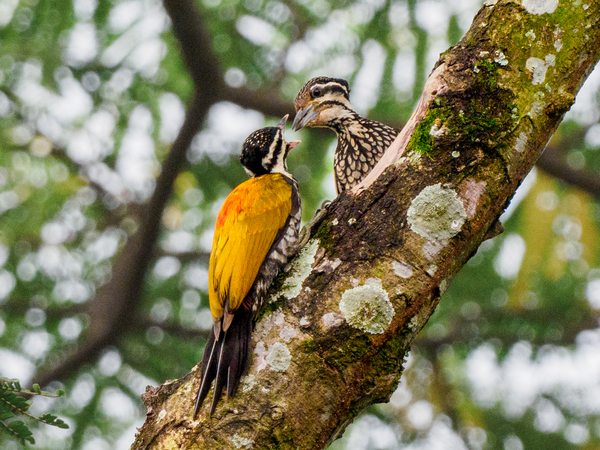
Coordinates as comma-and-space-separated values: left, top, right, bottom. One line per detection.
0, 0, 600, 450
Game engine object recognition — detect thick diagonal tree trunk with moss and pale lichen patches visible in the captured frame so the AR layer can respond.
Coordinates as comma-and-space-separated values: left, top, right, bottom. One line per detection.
132, 0, 600, 450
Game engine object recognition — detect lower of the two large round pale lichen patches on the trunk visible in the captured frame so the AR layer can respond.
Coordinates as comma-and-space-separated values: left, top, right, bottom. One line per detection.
339, 278, 394, 334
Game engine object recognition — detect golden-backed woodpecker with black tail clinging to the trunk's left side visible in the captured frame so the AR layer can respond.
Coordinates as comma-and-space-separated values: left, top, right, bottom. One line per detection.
193, 115, 301, 418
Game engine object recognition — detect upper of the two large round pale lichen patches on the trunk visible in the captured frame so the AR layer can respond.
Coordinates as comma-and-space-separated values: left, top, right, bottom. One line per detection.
407, 183, 467, 241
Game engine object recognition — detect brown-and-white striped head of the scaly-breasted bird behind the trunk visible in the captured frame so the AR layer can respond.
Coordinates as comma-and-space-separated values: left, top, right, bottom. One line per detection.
292, 77, 355, 131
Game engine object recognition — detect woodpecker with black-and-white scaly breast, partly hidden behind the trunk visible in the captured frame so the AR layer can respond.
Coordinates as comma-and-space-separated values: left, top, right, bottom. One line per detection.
292, 77, 398, 194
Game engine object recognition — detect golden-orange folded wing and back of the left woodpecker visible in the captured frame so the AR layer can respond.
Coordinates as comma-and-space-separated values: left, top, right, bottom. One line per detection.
208, 174, 292, 319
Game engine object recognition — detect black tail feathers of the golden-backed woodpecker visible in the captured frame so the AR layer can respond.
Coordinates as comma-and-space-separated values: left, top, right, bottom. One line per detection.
193, 306, 252, 418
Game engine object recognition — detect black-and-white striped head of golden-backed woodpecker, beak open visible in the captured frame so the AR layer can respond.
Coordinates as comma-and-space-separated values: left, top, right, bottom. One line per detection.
240, 114, 300, 177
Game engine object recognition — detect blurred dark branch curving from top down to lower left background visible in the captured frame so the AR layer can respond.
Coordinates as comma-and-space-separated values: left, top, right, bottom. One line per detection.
35, 0, 222, 386
